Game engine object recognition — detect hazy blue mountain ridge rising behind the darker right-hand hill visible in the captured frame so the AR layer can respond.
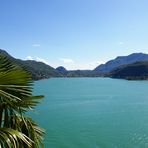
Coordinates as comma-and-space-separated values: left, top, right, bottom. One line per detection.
94, 53, 148, 73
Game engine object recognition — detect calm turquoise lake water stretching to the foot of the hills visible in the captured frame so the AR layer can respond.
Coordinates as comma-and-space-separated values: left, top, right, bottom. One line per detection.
32, 78, 148, 148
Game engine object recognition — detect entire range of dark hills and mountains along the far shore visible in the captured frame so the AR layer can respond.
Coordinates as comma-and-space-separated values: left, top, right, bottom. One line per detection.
0, 49, 148, 80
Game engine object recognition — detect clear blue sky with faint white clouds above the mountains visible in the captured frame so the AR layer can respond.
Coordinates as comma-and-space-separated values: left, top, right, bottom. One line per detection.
0, 0, 148, 69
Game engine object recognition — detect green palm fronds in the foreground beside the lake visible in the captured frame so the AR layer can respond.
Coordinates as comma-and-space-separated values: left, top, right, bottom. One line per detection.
0, 55, 44, 148
